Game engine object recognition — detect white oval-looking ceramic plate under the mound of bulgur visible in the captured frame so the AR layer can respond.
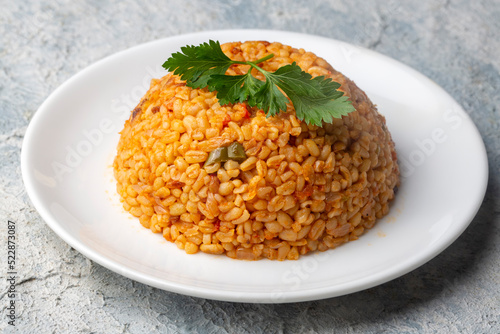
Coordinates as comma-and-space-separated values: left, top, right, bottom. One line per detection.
22, 30, 488, 303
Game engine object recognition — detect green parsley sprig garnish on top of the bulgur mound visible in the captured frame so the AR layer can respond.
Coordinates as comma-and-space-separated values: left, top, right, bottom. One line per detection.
163, 40, 355, 126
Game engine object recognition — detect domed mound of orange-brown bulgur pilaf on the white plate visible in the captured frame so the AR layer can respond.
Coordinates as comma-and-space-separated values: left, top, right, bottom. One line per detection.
114, 41, 399, 260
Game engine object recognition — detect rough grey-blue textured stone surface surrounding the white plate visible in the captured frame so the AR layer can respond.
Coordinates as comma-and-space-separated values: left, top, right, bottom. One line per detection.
0, 0, 500, 334
